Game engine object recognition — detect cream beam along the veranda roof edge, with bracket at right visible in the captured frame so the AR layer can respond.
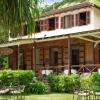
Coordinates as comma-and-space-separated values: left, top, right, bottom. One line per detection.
0, 31, 100, 48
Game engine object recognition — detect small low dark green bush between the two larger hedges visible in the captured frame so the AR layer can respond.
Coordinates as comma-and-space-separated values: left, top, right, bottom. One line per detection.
25, 82, 49, 94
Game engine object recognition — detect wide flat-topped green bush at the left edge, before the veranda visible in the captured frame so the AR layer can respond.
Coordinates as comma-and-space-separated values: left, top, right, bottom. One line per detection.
0, 70, 34, 86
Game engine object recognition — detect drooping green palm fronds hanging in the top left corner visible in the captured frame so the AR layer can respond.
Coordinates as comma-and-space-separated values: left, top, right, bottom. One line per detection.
0, 0, 41, 35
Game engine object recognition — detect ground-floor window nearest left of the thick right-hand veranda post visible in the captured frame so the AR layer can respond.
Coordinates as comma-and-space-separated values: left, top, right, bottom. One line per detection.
50, 48, 58, 66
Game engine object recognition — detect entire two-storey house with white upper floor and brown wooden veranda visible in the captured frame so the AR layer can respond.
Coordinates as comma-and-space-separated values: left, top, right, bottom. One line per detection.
1, 3, 100, 73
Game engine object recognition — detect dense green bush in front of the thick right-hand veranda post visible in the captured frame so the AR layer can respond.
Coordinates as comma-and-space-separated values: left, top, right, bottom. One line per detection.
47, 75, 80, 93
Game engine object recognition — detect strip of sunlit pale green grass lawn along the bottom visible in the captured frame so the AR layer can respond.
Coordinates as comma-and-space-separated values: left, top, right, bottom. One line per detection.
0, 93, 76, 100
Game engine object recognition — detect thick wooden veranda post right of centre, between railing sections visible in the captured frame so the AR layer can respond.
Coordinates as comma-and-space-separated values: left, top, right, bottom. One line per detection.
68, 35, 71, 74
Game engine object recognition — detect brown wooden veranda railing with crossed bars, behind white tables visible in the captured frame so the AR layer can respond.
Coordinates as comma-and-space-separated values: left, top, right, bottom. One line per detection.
37, 64, 100, 74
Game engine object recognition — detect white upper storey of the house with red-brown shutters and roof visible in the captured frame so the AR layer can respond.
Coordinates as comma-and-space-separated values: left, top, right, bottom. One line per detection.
9, 3, 100, 38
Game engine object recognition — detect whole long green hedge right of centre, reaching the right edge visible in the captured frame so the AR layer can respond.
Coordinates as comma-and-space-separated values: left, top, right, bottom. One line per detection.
47, 73, 100, 93
